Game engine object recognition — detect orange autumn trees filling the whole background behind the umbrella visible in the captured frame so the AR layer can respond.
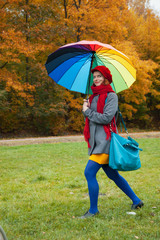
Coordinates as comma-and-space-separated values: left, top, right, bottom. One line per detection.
0, 0, 160, 135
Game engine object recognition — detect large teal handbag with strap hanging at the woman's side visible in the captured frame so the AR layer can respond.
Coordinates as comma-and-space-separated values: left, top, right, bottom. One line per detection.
109, 109, 142, 171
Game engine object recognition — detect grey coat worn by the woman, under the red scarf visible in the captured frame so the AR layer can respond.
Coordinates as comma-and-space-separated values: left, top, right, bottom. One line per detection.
83, 92, 118, 155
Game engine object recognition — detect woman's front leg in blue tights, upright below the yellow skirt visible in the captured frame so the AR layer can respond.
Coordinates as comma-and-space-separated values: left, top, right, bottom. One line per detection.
84, 160, 101, 214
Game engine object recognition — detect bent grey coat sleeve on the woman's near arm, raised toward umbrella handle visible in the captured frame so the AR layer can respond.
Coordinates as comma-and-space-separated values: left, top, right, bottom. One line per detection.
84, 93, 118, 125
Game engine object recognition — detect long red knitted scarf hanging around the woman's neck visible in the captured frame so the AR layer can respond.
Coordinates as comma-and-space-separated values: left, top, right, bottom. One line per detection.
83, 84, 116, 148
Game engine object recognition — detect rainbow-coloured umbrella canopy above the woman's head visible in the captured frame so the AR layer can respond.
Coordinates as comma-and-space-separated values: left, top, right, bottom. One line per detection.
45, 41, 136, 94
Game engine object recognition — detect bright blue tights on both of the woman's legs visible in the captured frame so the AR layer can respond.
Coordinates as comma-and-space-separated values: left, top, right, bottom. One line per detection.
84, 160, 141, 213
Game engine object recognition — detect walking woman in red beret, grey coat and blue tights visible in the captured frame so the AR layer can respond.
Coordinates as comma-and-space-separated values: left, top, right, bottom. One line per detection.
80, 66, 144, 218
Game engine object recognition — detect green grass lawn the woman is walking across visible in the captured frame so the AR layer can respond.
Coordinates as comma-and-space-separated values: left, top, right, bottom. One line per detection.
0, 138, 160, 240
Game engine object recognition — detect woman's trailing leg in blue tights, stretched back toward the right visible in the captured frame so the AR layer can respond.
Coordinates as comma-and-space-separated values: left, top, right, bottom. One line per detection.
102, 164, 141, 204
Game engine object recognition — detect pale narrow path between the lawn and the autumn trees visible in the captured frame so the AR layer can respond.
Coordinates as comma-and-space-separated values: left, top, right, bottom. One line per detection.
0, 132, 160, 146
